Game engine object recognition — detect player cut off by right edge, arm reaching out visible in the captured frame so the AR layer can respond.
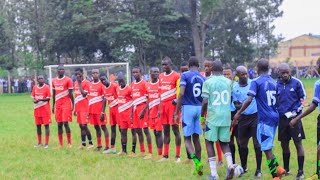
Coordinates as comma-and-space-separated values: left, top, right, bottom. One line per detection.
289, 58, 320, 180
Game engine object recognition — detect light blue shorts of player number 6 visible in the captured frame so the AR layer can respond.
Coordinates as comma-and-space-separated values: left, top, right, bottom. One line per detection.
182, 105, 202, 136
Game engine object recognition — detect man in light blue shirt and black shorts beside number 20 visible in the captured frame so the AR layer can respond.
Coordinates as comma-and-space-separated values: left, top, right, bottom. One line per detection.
232, 66, 262, 178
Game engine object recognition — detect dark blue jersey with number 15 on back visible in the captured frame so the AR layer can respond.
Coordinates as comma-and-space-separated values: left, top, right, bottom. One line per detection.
248, 75, 279, 126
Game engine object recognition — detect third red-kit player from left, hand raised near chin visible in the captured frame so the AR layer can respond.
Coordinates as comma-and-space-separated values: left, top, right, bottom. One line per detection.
74, 68, 93, 149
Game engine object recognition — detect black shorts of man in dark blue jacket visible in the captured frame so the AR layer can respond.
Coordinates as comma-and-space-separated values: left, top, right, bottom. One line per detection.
278, 116, 304, 142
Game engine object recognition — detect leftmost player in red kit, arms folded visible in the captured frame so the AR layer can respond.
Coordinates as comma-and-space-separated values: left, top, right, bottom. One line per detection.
31, 76, 51, 148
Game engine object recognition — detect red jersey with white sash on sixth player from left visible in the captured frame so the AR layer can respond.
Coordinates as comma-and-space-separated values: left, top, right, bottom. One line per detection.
117, 85, 132, 113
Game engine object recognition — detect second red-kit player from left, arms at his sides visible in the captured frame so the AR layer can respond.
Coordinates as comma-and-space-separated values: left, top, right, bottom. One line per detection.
52, 64, 74, 147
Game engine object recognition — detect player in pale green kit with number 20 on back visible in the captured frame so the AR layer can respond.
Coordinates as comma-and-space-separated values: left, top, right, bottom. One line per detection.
200, 60, 234, 179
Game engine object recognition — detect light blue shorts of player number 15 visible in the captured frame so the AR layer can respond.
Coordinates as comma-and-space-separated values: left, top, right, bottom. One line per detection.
257, 123, 277, 151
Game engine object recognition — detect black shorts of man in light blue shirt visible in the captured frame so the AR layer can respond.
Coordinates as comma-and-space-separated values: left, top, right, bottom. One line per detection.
238, 113, 259, 146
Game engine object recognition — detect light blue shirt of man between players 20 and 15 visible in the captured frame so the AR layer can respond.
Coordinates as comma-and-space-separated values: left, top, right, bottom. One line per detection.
232, 79, 257, 115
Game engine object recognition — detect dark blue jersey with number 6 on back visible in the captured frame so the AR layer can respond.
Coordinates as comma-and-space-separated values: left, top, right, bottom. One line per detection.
180, 70, 206, 106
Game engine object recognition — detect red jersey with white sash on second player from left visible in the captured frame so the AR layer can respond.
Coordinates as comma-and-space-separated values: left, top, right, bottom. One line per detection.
52, 76, 73, 107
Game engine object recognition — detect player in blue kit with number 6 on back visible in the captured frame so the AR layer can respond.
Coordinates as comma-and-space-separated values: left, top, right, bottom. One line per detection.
174, 57, 205, 176
